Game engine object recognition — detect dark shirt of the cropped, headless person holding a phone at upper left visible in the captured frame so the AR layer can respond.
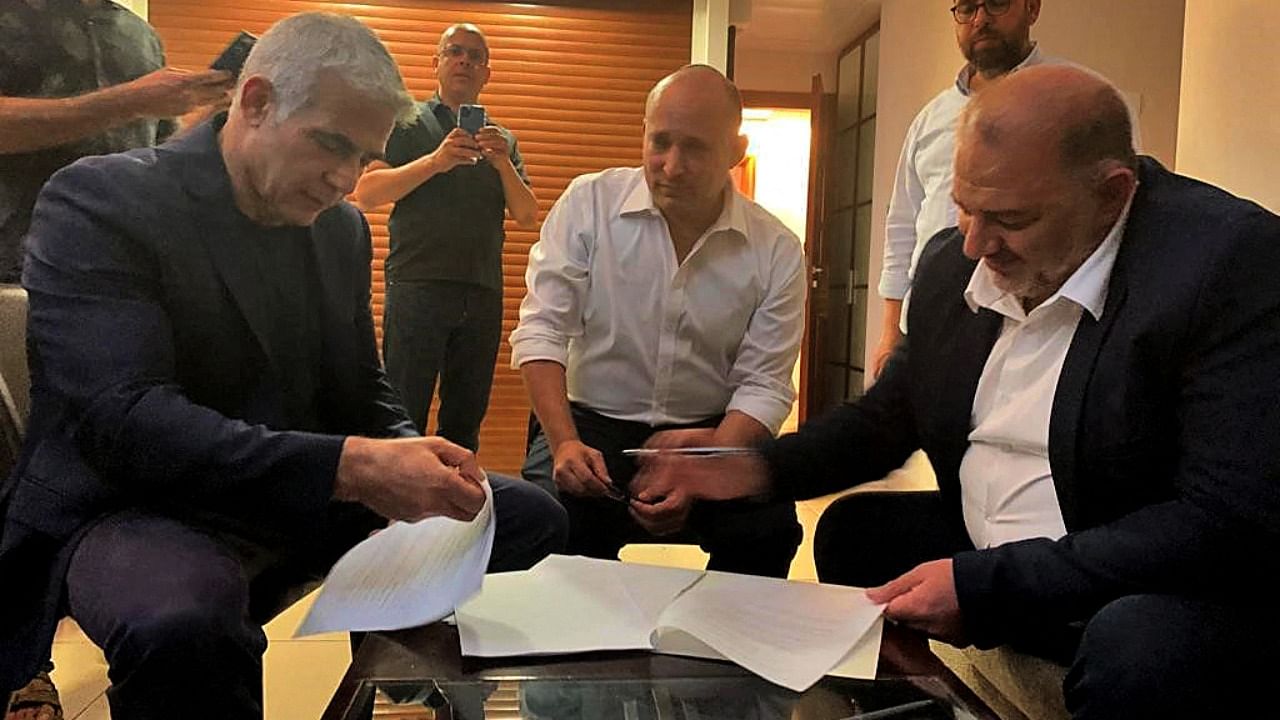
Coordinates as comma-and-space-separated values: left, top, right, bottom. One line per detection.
0, 0, 173, 282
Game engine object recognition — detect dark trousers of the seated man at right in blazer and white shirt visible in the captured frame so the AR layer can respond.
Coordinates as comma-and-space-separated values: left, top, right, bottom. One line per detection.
814, 484, 1280, 719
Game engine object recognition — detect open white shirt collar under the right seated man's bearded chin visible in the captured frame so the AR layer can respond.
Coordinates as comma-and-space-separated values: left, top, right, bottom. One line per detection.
964, 184, 1133, 320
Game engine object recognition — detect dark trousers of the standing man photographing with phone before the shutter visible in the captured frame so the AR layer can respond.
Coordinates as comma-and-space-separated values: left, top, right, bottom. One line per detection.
383, 281, 502, 451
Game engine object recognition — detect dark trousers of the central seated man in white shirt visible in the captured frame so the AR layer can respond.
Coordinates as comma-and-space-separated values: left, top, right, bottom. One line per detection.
521, 406, 803, 578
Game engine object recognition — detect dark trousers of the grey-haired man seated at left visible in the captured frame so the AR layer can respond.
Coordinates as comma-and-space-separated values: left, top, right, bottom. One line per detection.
67, 475, 568, 720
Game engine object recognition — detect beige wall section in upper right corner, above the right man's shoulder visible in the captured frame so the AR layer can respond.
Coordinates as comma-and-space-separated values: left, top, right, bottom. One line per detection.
1176, 0, 1280, 211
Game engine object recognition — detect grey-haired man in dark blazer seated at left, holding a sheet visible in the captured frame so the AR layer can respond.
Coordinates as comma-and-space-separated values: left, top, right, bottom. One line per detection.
0, 13, 567, 719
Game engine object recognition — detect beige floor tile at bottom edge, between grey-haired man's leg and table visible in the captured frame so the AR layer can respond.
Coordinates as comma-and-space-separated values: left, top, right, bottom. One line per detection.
264, 641, 351, 720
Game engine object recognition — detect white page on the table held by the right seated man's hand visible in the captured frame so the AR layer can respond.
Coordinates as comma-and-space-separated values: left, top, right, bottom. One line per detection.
653, 573, 883, 691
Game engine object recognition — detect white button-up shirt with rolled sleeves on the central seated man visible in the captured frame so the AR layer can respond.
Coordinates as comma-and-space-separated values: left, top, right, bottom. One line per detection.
511, 168, 805, 433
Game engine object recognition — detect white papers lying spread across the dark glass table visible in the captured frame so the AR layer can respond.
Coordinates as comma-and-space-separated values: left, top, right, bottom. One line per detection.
457, 555, 883, 691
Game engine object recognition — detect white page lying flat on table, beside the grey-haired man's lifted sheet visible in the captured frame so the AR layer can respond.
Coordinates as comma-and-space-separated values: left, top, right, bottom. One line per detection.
457, 555, 700, 657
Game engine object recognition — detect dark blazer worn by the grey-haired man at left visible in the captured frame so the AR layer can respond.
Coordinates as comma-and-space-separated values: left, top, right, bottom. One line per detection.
0, 124, 416, 688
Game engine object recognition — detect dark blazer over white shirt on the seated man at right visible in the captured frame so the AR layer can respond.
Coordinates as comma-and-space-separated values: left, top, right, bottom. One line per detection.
768, 158, 1280, 646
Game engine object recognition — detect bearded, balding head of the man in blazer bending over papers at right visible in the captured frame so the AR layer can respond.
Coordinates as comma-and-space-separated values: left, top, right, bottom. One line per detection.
952, 65, 1137, 311
